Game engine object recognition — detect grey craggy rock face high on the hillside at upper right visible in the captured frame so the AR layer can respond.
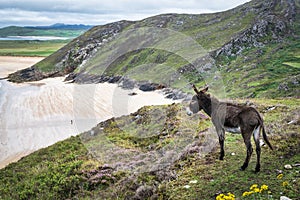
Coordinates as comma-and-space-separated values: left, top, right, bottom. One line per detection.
212, 0, 296, 57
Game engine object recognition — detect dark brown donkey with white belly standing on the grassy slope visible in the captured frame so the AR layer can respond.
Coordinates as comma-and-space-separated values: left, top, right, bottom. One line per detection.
187, 85, 273, 172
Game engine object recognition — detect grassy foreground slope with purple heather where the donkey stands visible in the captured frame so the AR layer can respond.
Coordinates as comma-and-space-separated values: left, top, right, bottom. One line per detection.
0, 99, 300, 199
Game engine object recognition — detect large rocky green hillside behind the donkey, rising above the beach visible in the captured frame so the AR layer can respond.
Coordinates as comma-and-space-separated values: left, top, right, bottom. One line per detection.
9, 0, 300, 97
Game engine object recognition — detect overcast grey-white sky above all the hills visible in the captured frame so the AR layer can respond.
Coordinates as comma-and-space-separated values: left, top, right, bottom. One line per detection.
0, 0, 249, 27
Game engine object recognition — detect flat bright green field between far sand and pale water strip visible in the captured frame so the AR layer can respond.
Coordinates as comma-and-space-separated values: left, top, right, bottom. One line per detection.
0, 40, 69, 57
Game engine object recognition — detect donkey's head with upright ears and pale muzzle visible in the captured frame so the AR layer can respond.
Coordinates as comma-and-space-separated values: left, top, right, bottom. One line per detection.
187, 85, 211, 115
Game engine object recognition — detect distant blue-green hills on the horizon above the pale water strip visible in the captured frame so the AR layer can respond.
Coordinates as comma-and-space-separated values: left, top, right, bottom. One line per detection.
0, 23, 92, 37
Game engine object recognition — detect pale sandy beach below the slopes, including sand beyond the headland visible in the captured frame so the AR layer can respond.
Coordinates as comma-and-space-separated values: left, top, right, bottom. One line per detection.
0, 57, 178, 168
